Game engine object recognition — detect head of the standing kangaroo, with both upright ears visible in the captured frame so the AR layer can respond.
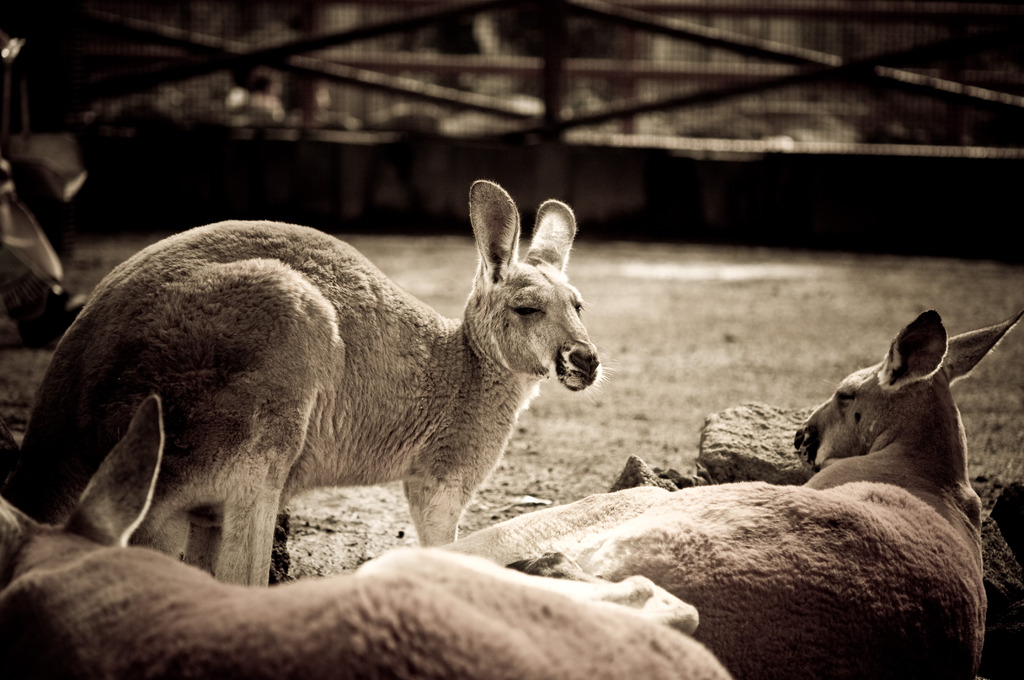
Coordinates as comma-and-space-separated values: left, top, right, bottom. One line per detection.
466, 180, 601, 390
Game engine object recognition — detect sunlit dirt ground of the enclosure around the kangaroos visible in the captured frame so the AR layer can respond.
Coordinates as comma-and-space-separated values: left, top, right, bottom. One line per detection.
0, 229, 1024, 578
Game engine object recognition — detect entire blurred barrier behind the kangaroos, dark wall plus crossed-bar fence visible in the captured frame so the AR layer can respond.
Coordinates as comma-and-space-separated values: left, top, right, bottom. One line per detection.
0, 0, 1024, 261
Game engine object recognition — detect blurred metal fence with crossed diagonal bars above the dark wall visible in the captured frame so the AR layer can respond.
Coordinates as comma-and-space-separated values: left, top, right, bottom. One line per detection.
68, 0, 1024, 158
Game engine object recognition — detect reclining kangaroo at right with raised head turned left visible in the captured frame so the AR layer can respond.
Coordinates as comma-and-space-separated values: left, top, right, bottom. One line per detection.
449, 311, 1021, 680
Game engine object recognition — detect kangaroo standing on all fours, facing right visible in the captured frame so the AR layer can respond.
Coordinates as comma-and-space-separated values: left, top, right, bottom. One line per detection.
4, 180, 600, 584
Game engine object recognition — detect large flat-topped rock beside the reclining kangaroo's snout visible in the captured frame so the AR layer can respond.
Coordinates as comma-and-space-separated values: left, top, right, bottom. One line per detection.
697, 403, 813, 484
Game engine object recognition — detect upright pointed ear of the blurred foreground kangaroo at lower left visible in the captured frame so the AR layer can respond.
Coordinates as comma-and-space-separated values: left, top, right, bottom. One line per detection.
66, 395, 164, 547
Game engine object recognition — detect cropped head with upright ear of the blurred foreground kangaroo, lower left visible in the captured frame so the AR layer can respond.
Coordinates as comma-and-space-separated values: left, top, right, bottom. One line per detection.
0, 395, 164, 589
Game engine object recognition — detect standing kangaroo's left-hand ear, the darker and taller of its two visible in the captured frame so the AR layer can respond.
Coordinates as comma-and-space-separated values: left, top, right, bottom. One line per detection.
469, 179, 519, 284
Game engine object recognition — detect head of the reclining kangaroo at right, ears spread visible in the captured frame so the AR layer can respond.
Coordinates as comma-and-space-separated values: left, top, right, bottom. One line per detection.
795, 311, 1024, 470
